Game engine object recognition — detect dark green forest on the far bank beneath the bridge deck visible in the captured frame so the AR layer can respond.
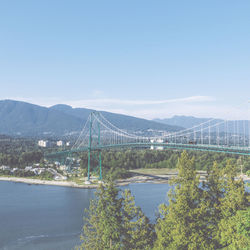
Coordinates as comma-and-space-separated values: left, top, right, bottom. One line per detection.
78, 149, 250, 179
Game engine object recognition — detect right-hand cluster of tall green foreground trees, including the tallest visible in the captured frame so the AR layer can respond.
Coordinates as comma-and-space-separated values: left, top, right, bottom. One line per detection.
155, 151, 249, 249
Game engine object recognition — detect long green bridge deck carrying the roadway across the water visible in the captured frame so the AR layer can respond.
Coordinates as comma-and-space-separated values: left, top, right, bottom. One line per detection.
45, 142, 250, 158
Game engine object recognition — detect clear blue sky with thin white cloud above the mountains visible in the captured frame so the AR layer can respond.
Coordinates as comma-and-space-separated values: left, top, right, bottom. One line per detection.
0, 0, 250, 119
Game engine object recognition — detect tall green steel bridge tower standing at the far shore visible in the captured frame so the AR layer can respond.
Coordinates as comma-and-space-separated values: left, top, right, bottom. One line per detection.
88, 111, 102, 181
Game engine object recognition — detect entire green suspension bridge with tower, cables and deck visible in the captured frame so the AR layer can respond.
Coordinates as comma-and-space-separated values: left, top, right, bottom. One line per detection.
46, 111, 250, 180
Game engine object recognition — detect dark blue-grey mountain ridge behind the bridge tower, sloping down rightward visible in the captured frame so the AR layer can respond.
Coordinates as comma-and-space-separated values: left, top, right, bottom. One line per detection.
0, 100, 182, 136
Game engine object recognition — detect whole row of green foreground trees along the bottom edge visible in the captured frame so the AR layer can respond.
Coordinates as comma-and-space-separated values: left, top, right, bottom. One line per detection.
78, 151, 250, 250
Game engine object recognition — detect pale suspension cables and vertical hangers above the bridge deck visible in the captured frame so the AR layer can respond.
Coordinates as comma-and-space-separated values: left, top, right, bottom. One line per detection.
69, 112, 250, 149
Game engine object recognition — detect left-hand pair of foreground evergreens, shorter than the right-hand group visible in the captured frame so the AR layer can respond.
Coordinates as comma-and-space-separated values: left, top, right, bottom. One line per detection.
78, 182, 154, 250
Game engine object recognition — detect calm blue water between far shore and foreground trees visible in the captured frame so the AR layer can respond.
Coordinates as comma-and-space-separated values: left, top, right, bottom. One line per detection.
0, 181, 170, 250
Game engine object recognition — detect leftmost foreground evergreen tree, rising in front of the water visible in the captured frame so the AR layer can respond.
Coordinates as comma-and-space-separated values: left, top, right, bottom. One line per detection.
79, 182, 123, 250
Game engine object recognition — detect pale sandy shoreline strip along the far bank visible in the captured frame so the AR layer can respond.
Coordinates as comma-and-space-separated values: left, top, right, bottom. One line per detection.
0, 174, 250, 189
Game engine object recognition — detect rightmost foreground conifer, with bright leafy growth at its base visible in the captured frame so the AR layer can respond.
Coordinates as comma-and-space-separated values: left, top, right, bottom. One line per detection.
217, 161, 250, 249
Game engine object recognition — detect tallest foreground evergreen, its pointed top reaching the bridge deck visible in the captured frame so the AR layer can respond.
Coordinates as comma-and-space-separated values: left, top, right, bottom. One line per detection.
155, 151, 214, 250
